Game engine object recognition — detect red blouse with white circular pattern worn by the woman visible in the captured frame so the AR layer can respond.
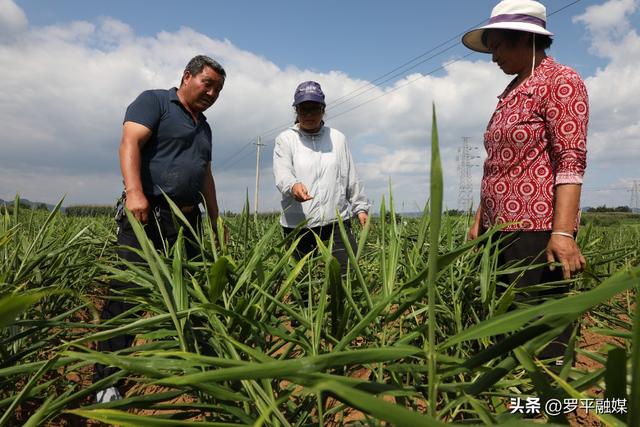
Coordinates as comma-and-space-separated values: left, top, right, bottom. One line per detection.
480, 57, 589, 231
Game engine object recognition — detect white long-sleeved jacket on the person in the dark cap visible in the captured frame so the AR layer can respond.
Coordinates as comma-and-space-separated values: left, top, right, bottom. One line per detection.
273, 126, 370, 228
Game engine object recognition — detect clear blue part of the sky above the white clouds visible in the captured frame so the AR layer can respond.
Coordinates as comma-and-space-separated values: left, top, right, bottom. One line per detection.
16, 0, 601, 80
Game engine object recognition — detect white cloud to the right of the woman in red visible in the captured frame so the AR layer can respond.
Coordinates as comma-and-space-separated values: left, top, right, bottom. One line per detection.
574, 0, 640, 194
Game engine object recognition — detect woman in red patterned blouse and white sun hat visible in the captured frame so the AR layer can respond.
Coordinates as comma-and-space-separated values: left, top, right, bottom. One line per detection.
462, 0, 589, 362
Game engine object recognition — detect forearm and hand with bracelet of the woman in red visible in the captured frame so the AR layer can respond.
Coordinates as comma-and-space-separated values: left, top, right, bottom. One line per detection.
547, 184, 586, 279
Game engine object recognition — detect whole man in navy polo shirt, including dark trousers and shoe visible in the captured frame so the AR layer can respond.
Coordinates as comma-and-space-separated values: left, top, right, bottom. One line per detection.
94, 55, 226, 403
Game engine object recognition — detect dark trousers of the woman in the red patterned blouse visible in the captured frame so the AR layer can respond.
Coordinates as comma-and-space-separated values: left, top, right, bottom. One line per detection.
498, 231, 574, 359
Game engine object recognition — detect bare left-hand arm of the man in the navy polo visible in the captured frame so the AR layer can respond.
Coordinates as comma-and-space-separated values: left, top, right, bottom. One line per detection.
120, 122, 152, 224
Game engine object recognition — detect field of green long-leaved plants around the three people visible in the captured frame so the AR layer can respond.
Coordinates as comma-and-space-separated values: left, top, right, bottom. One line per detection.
0, 199, 640, 426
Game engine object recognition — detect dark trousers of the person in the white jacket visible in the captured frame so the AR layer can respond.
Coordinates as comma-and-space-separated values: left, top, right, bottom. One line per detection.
282, 221, 358, 274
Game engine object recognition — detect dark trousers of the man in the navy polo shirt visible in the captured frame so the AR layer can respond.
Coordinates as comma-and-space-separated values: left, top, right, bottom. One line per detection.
93, 201, 200, 382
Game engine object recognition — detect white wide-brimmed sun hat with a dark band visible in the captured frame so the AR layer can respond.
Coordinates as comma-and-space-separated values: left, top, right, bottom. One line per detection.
462, 0, 553, 53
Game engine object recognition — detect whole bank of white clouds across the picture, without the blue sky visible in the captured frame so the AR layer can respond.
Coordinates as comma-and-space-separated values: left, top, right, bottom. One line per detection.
0, 0, 640, 210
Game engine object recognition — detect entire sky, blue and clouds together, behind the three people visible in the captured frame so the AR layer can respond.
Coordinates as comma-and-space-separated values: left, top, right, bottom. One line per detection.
0, 0, 640, 210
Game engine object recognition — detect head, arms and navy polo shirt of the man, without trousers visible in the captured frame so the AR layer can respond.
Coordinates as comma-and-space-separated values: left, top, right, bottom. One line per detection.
120, 55, 226, 224
